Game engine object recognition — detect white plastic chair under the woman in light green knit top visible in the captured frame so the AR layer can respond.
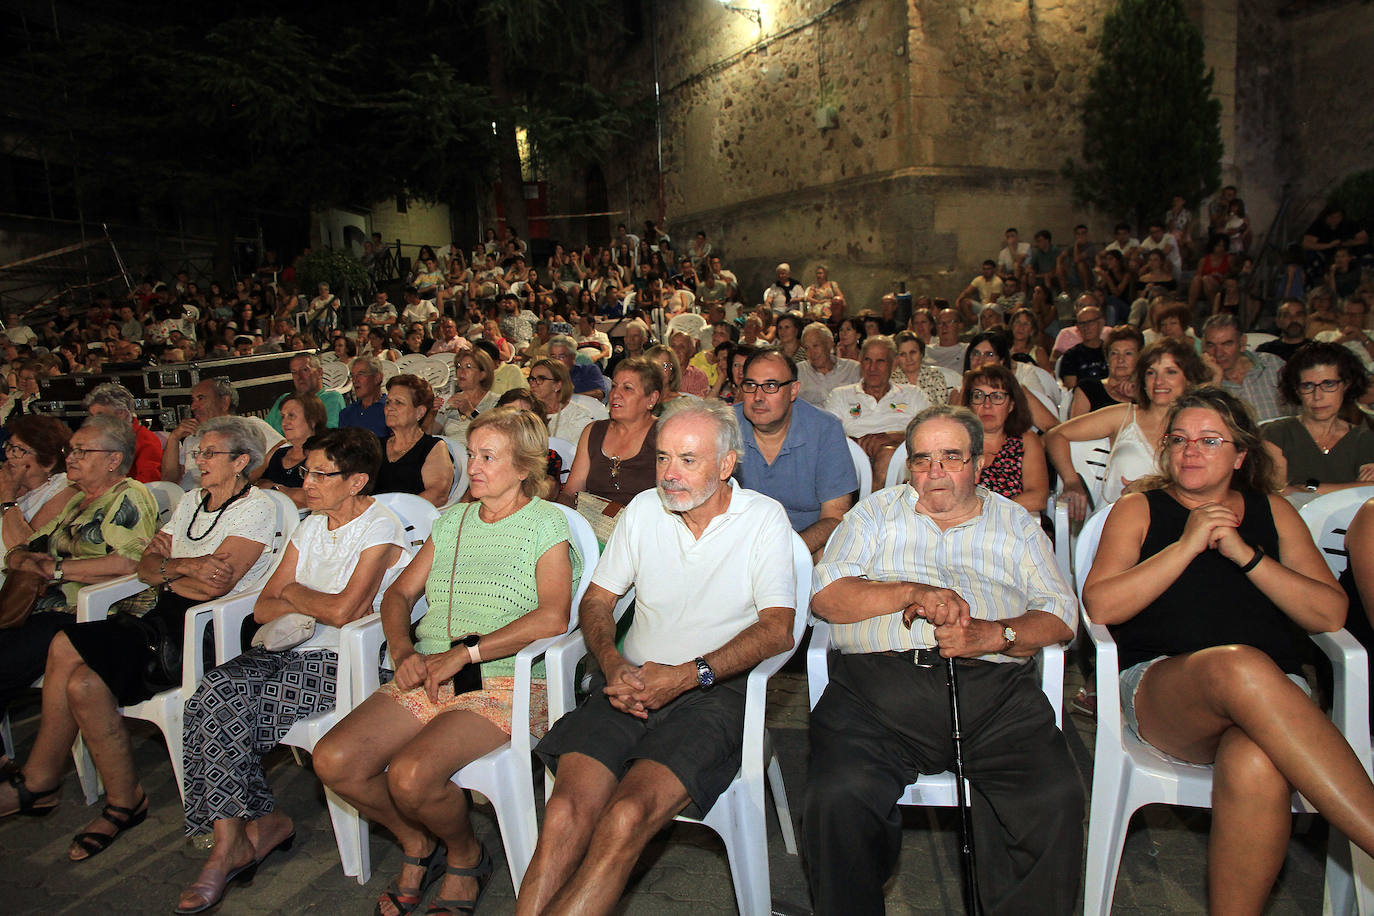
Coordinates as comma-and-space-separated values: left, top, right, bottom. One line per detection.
331, 505, 599, 894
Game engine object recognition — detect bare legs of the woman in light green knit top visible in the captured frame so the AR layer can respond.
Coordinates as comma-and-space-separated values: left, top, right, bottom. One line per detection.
315, 694, 510, 900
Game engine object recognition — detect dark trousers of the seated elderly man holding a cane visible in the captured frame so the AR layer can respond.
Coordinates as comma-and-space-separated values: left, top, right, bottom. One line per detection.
802, 655, 1083, 916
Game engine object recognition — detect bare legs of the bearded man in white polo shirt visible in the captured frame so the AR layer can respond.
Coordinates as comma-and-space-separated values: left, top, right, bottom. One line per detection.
515, 754, 691, 916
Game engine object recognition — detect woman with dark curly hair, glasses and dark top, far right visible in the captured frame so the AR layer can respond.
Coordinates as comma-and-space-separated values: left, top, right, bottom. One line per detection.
1260, 342, 1374, 496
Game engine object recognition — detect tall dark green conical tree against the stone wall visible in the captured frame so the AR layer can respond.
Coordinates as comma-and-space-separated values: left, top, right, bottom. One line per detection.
1065, 0, 1221, 224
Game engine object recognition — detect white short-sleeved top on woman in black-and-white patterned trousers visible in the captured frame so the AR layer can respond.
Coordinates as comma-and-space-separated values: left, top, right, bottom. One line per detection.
291, 500, 411, 610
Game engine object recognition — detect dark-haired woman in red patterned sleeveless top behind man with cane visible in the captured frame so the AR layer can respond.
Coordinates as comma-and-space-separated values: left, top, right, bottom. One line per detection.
960, 363, 1050, 512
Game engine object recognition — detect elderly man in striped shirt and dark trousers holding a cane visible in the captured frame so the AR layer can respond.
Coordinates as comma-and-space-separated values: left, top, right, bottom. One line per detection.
802, 407, 1083, 916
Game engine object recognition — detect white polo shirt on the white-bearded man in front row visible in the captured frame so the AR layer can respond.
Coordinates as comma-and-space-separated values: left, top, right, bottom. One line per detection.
592, 481, 797, 665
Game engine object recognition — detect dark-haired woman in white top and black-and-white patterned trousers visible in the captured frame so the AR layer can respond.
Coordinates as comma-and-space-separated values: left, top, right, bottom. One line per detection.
176, 420, 411, 913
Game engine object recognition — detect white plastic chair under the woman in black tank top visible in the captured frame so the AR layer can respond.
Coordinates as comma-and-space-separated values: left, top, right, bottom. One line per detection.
1076, 505, 1374, 916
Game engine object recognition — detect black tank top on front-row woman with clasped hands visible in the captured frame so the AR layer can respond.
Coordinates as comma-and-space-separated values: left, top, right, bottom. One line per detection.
1110, 490, 1303, 674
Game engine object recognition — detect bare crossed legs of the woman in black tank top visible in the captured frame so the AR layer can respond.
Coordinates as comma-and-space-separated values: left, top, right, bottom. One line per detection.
1136, 645, 1374, 913
